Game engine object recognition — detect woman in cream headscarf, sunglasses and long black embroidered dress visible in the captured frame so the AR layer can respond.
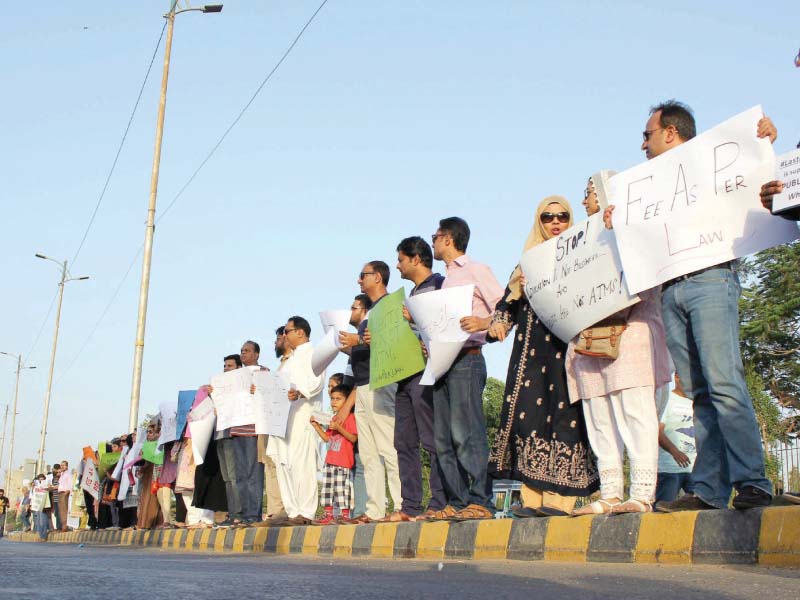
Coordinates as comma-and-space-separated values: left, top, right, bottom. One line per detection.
487, 196, 599, 517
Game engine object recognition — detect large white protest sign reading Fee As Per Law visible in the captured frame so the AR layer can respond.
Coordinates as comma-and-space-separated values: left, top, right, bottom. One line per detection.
610, 107, 798, 293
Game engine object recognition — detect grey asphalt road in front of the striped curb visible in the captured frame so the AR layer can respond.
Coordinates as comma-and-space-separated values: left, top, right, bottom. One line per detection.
0, 540, 800, 600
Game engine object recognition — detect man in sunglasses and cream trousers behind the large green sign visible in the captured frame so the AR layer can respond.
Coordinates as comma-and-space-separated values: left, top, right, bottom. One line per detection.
336, 260, 402, 523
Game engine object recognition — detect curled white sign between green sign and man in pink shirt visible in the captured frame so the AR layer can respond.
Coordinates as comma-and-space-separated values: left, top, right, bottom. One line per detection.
406, 284, 475, 385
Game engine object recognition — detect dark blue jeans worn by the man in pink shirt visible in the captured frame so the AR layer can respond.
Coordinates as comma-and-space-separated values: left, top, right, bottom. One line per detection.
433, 354, 493, 510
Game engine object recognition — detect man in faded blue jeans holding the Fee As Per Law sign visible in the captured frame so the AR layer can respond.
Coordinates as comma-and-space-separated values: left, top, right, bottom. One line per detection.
642, 100, 778, 512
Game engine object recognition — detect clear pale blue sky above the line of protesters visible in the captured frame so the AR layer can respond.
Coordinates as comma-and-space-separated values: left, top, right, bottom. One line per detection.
0, 0, 800, 481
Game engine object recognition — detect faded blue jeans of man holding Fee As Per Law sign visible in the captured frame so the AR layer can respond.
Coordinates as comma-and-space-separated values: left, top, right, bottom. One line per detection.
661, 267, 772, 508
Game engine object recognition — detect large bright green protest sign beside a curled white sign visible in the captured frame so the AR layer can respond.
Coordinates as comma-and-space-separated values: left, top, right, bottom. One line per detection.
367, 288, 425, 390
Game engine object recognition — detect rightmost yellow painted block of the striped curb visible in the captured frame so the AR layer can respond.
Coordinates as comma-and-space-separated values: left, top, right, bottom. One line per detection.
758, 506, 800, 567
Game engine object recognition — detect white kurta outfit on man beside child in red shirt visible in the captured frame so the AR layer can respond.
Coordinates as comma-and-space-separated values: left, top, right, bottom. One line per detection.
267, 343, 325, 519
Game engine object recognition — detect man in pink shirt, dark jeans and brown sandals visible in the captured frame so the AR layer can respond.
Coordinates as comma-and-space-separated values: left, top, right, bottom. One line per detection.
432, 217, 503, 520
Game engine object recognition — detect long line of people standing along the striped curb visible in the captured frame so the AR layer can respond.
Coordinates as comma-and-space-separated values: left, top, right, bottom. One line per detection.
7, 101, 800, 540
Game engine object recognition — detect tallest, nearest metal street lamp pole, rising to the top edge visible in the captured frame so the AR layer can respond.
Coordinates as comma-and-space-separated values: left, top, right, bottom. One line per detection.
128, 9, 175, 431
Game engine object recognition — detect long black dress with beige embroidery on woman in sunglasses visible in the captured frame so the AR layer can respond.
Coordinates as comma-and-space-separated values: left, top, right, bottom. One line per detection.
487, 289, 600, 496
